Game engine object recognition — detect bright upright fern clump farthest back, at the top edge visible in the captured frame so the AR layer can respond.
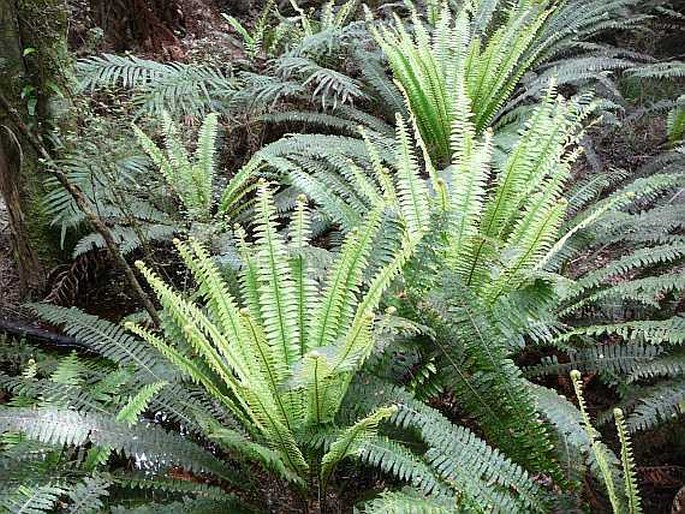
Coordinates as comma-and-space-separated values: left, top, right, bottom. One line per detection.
372, 2, 635, 166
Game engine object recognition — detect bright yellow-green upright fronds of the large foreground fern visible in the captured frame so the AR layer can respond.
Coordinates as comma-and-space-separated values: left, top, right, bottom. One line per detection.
129, 183, 414, 480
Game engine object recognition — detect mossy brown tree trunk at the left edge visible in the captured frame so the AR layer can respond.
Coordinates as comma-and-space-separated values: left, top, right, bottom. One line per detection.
0, 0, 73, 292
